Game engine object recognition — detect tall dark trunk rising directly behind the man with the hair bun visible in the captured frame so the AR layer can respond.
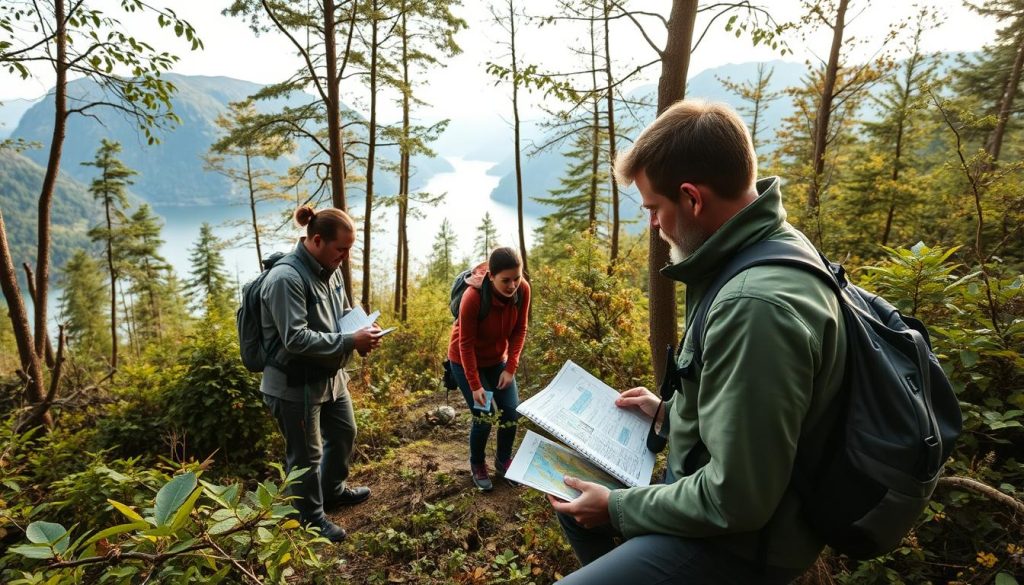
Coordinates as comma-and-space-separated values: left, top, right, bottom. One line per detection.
325, 0, 354, 307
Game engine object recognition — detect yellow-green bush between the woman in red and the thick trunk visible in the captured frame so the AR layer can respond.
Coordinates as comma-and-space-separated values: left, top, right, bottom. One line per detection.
525, 234, 651, 389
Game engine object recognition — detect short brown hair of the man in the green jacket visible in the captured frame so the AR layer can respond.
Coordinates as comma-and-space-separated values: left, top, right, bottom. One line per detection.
615, 99, 758, 202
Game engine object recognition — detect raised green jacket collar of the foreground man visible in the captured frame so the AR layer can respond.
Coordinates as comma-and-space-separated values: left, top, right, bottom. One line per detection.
662, 176, 785, 284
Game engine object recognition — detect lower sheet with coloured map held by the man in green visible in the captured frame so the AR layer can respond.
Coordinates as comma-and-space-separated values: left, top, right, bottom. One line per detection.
505, 430, 624, 501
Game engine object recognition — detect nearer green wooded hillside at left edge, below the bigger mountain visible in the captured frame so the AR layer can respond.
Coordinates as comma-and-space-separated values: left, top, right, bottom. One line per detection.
0, 150, 101, 277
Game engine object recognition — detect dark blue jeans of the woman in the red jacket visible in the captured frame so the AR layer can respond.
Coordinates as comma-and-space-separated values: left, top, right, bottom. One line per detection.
452, 362, 519, 465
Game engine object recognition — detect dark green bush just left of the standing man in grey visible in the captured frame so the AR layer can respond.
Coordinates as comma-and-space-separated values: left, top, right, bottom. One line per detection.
164, 317, 276, 466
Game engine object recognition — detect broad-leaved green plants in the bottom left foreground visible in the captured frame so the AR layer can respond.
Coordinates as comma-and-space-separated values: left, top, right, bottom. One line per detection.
0, 466, 326, 585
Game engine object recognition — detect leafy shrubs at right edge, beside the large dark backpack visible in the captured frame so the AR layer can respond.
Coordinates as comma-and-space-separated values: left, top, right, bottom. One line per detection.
843, 244, 1024, 583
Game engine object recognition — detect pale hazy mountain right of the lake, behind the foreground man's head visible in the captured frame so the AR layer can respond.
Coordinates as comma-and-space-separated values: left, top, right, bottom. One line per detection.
490, 60, 807, 216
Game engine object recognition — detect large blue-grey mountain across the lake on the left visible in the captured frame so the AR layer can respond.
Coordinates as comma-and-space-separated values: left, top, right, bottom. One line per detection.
12, 74, 451, 206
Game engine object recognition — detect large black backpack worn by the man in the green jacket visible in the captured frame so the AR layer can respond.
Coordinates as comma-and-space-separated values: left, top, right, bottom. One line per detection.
677, 241, 963, 558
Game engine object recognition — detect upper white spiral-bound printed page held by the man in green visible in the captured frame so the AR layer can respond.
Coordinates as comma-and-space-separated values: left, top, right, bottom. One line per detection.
516, 361, 654, 487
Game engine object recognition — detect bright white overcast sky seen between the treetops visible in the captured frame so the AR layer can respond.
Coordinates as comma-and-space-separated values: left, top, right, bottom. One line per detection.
0, 0, 996, 119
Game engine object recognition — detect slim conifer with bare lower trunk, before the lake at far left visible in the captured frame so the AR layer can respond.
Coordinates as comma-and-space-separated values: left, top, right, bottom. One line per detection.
82, 138, 137, 369
